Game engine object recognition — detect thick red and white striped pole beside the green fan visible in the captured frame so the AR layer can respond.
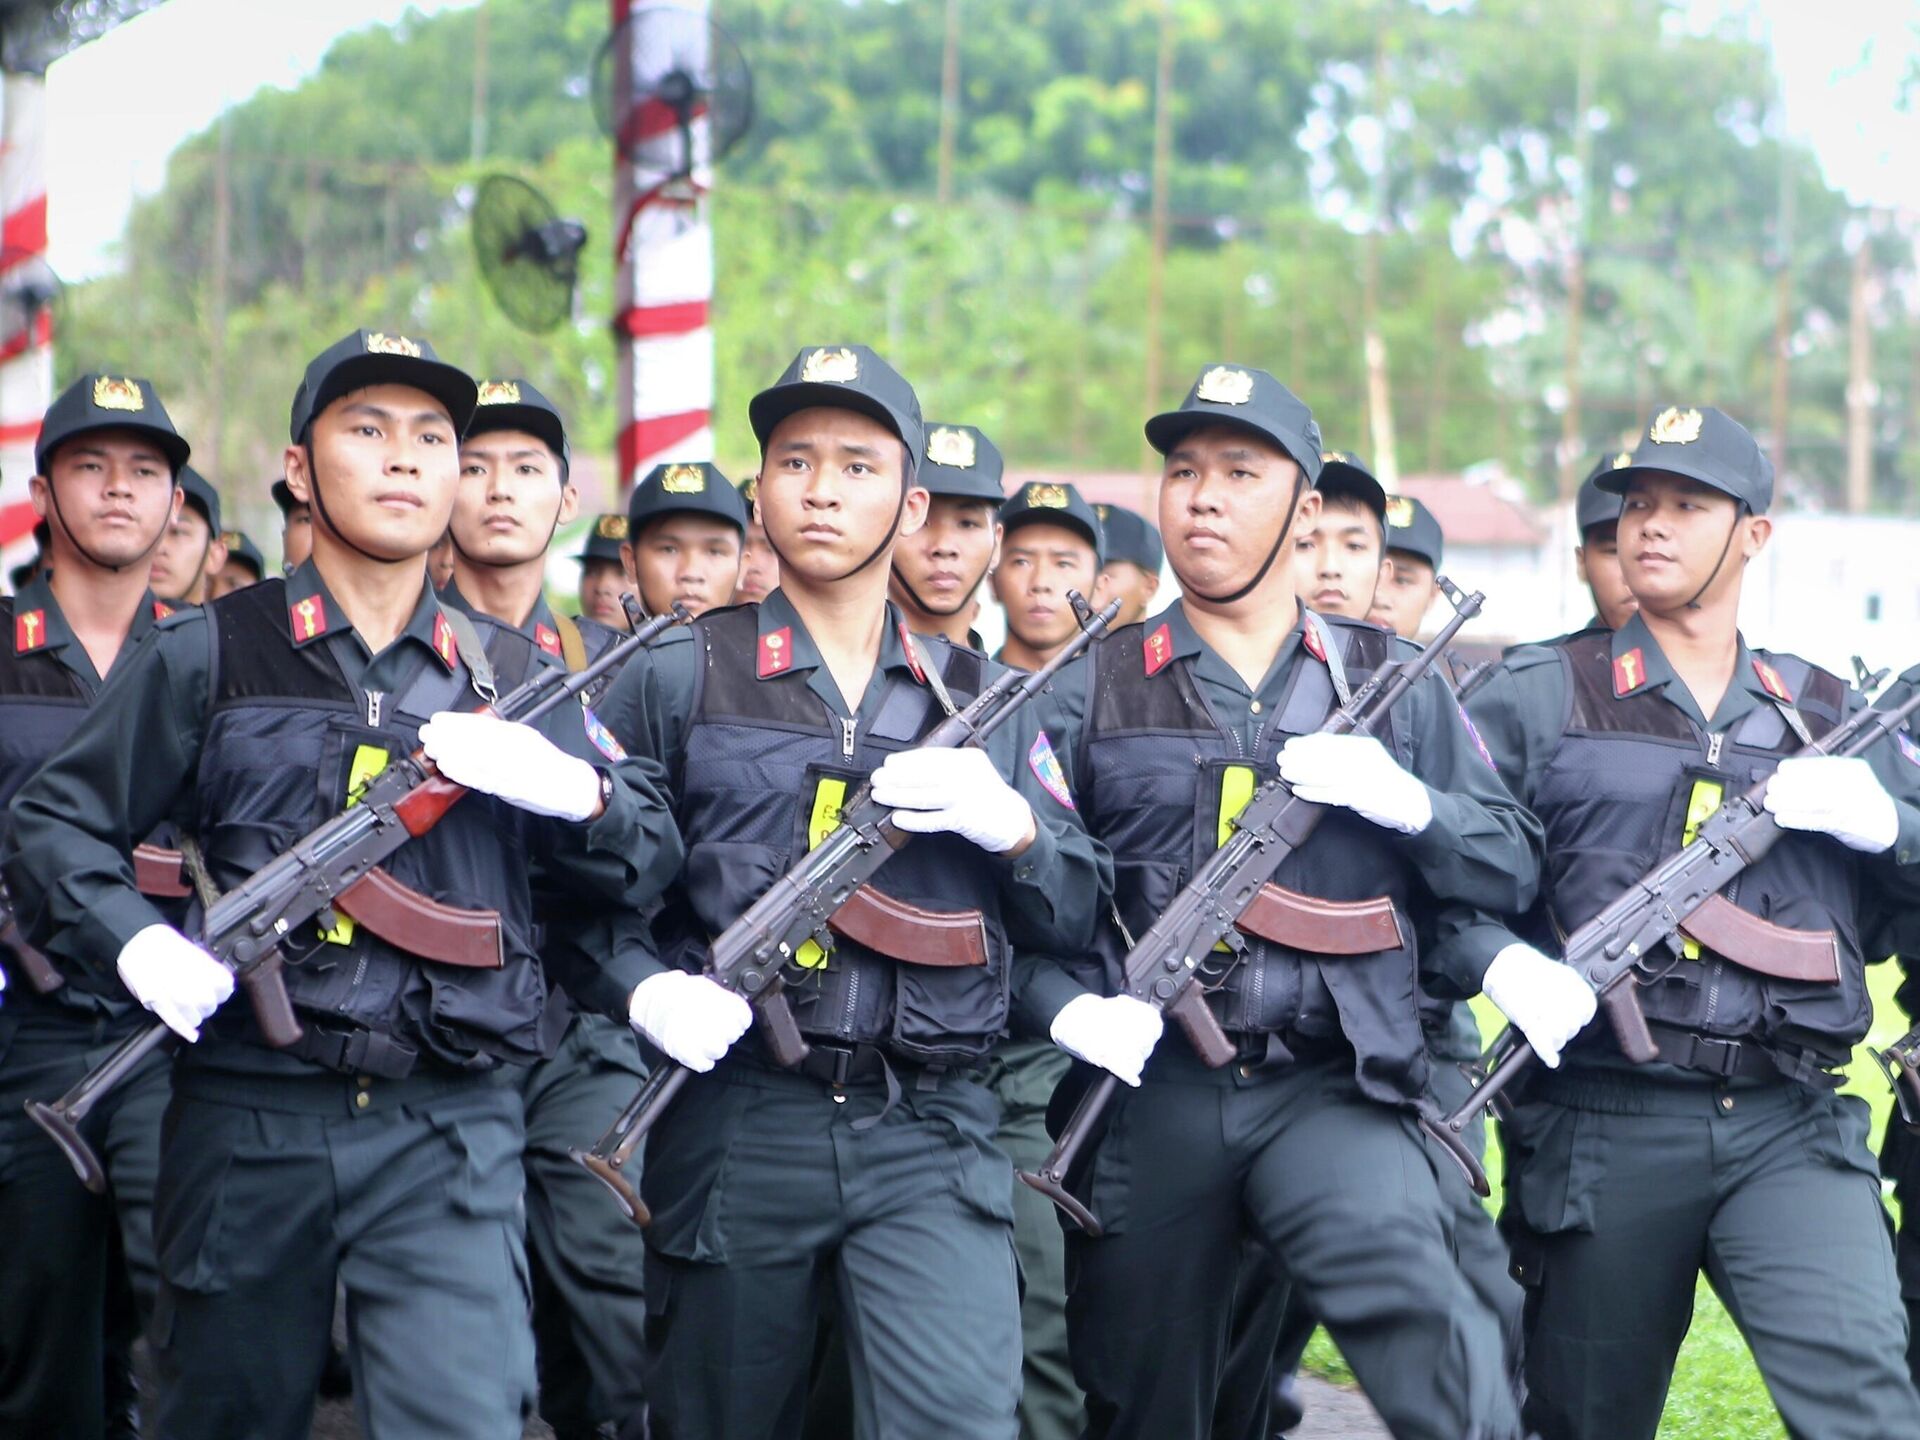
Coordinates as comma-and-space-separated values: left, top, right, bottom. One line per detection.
612, 0, 714, 501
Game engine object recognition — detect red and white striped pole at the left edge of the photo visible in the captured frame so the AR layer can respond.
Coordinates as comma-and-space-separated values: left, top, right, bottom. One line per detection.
0, 73, 54, 564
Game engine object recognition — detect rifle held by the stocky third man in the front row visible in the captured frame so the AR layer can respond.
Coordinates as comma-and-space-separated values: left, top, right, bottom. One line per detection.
1020, 576, 1486, 1236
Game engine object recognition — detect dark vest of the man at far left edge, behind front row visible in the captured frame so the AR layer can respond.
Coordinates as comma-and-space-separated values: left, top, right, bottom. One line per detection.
0, 599, 186, 1016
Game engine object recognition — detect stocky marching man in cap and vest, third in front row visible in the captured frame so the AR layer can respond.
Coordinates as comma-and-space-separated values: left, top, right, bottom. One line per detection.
1054, 365, 1592, 1440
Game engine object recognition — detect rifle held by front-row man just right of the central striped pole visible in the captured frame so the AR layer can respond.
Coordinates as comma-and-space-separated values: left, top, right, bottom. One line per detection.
568, 589, 1119, 1225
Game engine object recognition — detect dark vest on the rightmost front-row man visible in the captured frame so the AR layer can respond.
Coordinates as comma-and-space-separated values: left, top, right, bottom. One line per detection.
1534, 632, 1872, 1064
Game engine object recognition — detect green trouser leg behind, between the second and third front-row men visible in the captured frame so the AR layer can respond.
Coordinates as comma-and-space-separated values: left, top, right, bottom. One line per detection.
987, 1041, 1085, 1440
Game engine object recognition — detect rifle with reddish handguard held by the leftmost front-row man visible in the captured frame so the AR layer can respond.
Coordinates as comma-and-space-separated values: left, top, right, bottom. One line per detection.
27, 605, 689, 1194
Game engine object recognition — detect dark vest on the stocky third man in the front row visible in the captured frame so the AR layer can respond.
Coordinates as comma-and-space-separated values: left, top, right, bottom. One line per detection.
1075, 616, 1427, 1102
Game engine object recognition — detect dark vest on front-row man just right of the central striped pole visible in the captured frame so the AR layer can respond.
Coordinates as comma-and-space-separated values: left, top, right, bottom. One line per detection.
655, 605, 1012, 1064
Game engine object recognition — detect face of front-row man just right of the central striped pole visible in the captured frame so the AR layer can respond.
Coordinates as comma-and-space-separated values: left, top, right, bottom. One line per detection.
755, 409, 927, 586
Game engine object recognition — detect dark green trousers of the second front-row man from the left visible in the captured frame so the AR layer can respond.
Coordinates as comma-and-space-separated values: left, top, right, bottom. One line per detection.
643, 1058, 1020, 1440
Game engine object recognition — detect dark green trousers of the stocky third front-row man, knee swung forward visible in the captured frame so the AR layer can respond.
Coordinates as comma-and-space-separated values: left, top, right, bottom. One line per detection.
1068, 1044, 1519, 1440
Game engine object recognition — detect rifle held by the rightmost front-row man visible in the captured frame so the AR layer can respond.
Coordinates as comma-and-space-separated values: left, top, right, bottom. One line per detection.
1442, 687, 1920, 1196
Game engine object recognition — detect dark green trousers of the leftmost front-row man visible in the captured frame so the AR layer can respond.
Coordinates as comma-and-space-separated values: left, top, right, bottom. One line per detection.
154, 1068, 537, 1440
